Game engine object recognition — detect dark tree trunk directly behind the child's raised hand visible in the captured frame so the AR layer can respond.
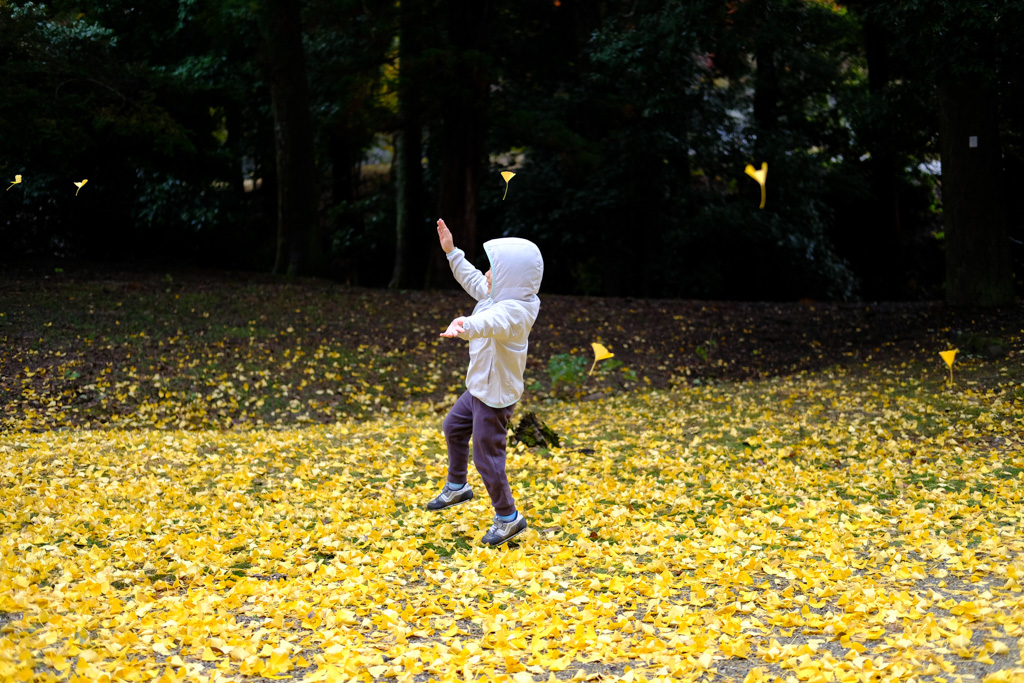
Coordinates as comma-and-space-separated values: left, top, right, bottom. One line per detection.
428, 0, 493, 286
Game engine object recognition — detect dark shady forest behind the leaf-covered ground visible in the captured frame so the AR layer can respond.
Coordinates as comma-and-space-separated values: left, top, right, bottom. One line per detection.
0, 0, 1024, 305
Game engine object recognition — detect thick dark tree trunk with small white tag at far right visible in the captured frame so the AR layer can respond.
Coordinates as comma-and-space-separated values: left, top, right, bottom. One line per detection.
939, 76, 1014, 306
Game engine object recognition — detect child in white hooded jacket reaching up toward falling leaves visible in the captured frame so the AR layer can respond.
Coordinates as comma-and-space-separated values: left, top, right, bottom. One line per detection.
427, 220, 544, 546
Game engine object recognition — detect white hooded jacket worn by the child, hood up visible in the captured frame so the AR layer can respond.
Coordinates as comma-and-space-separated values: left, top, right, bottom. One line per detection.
447, 238, 544, 408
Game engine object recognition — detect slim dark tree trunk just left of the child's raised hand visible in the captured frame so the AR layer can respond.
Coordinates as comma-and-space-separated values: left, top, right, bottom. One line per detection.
388, 0, 425, 289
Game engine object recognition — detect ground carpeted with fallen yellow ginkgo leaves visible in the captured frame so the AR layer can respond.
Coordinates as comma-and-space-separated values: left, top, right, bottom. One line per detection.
0, 270, 1024, 682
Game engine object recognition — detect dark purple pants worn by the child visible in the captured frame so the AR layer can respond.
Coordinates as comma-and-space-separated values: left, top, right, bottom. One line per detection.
441, 391, 515, 515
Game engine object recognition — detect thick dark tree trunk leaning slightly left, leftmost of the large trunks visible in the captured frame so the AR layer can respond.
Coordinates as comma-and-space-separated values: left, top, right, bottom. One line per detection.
262, 0, 324, 275
